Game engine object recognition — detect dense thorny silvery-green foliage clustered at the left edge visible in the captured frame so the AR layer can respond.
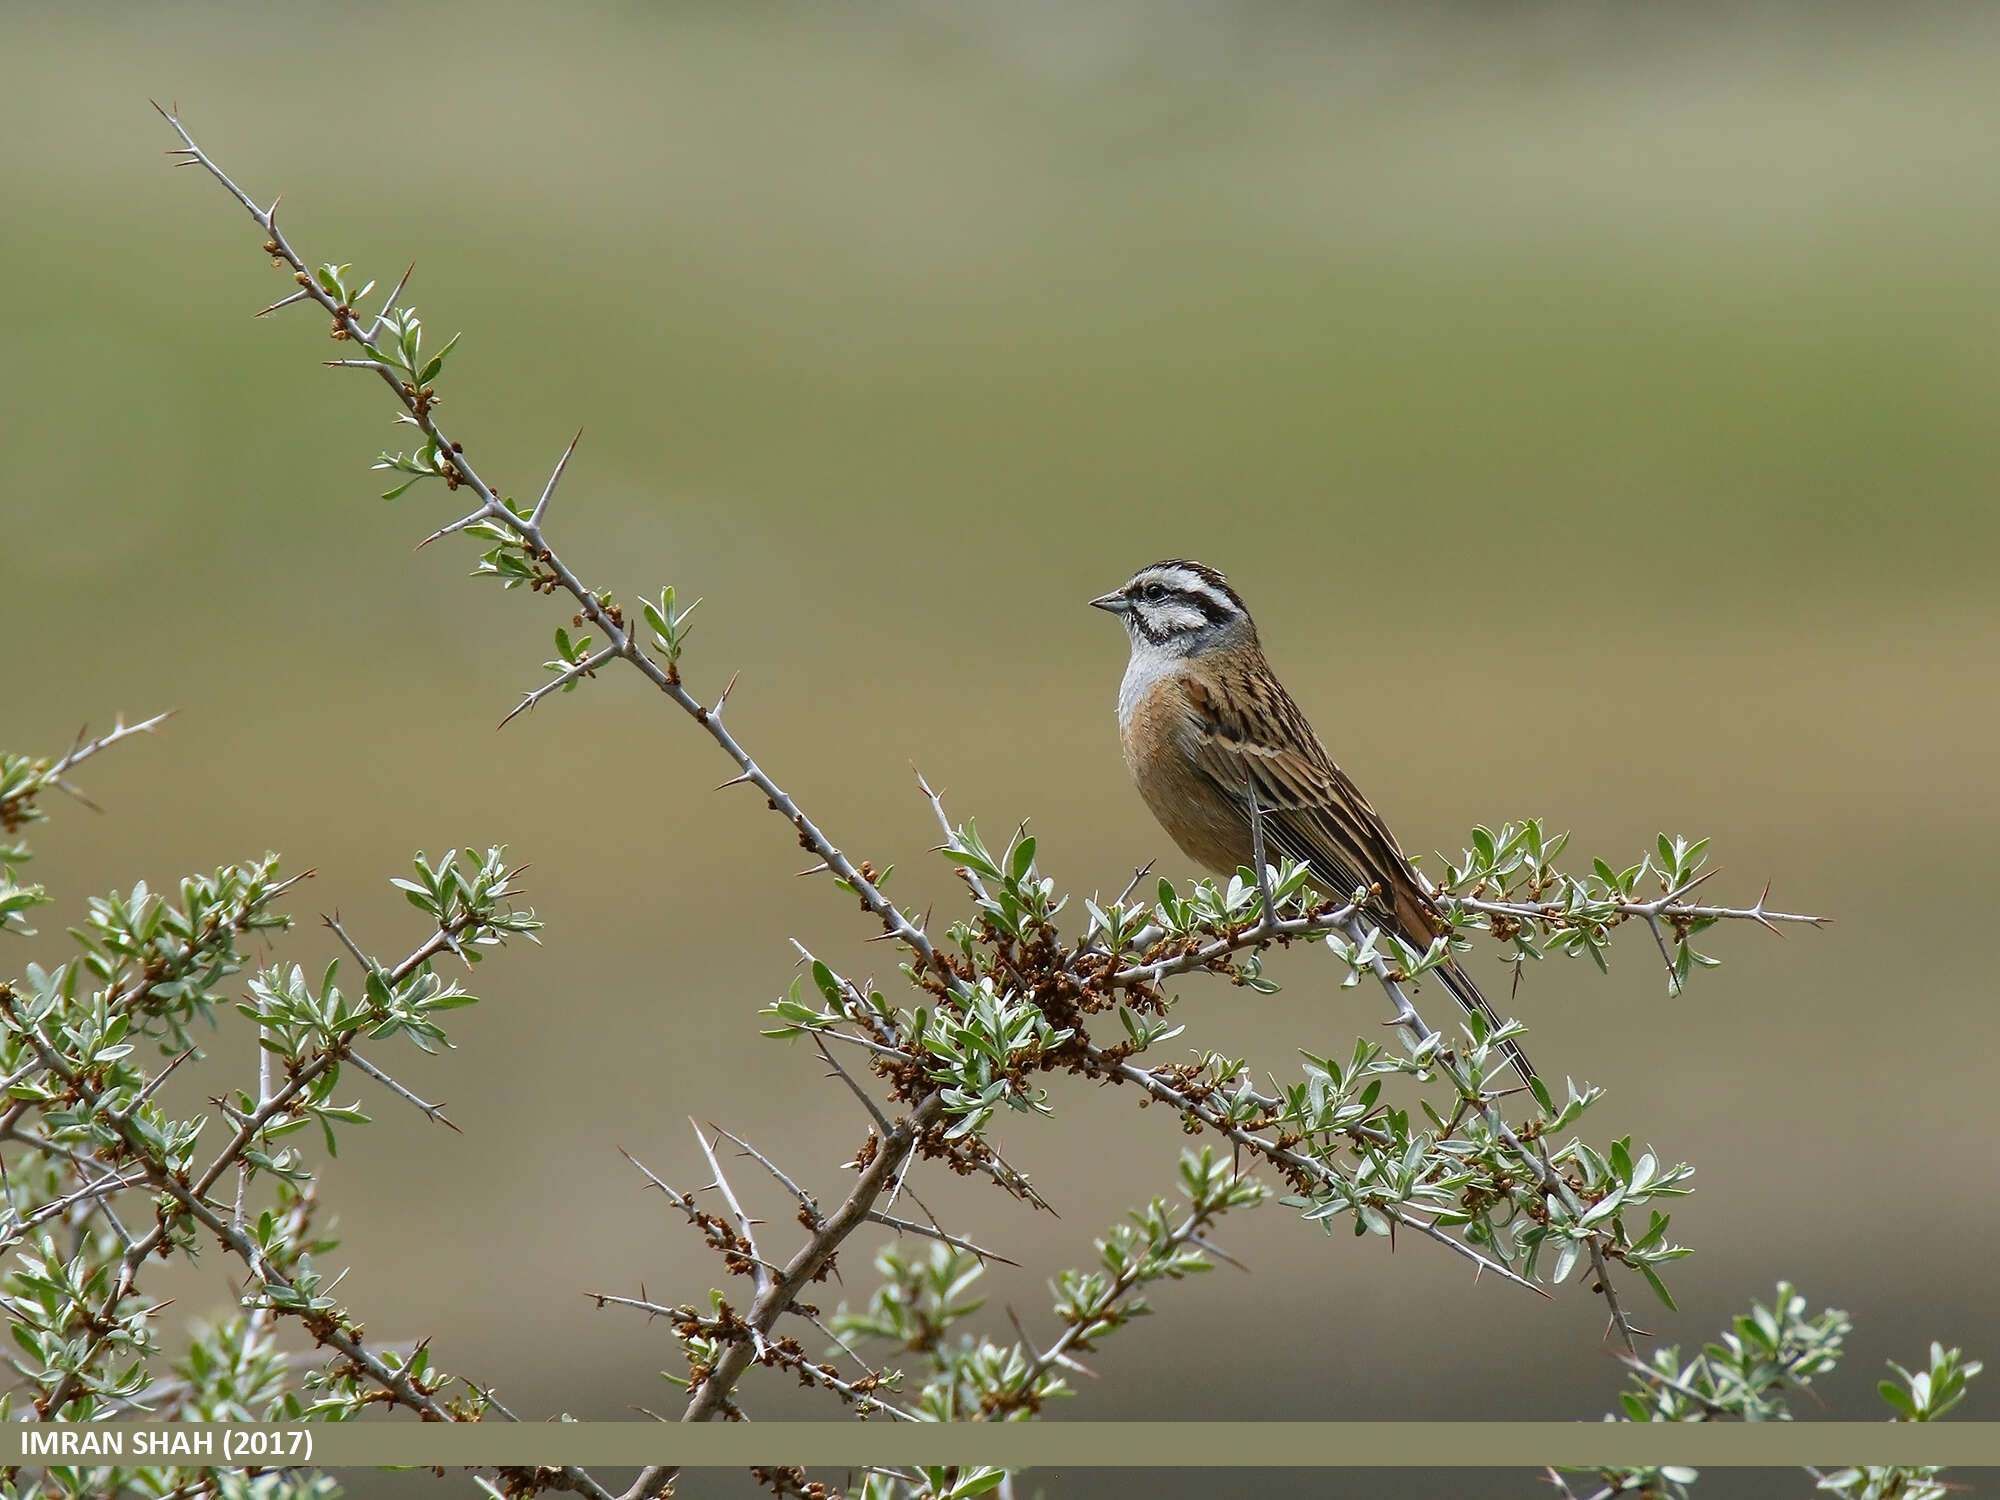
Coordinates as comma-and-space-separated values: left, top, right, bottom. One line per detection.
0, 736, 540, 1500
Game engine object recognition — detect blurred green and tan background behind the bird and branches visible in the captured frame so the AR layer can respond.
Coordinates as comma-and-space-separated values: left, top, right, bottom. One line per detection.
0, 0, 2000, 1494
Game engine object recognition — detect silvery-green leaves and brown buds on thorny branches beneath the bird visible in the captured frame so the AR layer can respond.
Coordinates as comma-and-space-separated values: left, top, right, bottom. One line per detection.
768, 824, 1692, 1306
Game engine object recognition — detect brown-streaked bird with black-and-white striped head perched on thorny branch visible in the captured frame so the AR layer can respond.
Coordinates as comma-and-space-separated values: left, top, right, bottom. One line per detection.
1090, 558, 1534, 1084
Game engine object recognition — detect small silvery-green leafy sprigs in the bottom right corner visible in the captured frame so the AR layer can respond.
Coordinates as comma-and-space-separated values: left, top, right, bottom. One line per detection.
1560, 1282, 1982, 1500
